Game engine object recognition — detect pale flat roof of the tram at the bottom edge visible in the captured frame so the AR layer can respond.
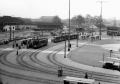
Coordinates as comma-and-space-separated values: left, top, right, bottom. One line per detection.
64, 76, 95, 84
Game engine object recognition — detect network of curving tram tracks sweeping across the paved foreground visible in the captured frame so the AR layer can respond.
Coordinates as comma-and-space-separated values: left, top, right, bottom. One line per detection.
0, 43, 120, 84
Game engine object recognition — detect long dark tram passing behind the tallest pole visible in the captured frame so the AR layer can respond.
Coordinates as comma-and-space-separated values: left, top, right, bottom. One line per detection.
51, 34, 78, 43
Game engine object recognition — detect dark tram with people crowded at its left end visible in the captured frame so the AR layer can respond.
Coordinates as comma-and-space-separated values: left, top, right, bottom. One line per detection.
21, 38, 48, 49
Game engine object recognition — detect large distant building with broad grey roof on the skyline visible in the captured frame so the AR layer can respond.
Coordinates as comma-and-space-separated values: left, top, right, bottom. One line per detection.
34, 16, 63, 31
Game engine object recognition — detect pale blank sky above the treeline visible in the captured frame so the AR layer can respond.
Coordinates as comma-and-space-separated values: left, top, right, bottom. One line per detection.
0, 0, 120, 19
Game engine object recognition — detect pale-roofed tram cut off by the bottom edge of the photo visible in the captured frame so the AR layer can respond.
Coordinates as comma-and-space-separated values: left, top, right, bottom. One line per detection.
63, 76, 95, 84
